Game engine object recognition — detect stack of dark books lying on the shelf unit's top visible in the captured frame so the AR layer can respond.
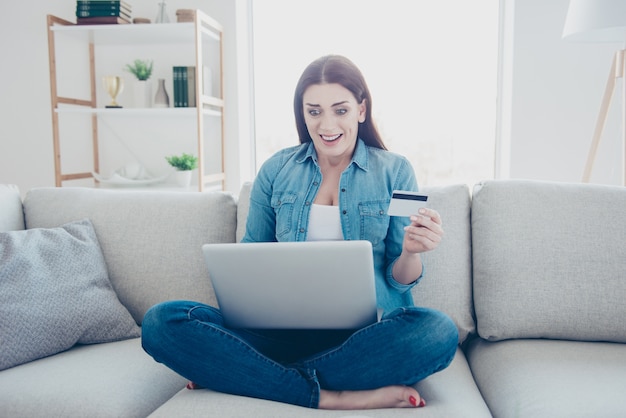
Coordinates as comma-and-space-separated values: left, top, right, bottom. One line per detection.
76, 0, 132, 25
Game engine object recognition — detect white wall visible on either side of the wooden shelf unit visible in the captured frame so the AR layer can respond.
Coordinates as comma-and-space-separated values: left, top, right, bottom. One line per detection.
0, 0, 253, 193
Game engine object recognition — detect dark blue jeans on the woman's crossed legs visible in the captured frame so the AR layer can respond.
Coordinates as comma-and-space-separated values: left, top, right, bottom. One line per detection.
142, 301, 458, 408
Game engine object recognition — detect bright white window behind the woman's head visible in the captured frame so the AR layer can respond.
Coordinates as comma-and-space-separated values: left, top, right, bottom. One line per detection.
252, 0, 498, 186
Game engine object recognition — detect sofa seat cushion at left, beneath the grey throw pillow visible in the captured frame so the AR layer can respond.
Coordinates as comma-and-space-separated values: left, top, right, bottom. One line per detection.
0, 338, 187, 418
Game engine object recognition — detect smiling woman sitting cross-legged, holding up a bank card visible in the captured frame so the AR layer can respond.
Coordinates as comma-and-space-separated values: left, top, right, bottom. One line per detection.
143, 55, 458, 409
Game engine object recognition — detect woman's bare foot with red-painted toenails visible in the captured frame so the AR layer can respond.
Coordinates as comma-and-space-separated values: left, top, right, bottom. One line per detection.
319, 386, 426, 409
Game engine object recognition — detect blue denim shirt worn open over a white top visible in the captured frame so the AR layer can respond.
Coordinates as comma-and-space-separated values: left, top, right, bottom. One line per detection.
242, 139, 421, 312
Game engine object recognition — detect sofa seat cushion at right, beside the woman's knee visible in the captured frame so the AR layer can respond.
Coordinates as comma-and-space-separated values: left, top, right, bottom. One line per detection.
467, 339, 626, 418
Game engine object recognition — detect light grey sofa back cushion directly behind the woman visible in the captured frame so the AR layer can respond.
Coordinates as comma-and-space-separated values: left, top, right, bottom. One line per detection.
237, 183, 475, 342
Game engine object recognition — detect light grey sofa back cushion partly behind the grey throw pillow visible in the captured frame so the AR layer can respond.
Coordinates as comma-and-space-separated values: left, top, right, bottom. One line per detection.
24, 188, 237, 323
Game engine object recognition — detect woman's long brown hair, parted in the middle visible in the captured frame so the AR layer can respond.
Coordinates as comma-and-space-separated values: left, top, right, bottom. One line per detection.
293, 55, 387, 150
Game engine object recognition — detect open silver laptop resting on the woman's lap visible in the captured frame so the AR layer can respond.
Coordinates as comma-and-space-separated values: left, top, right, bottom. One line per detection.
202, 241, 378, 329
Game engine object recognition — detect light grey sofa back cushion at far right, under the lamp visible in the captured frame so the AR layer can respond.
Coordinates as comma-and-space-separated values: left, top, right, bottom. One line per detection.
472, 180, 626, 342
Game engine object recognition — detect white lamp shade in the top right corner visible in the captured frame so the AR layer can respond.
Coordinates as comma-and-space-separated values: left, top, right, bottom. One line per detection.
563, 0, 626, 43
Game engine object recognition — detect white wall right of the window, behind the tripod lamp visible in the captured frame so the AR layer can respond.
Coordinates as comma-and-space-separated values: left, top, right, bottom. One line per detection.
502, 0, 622, 185
